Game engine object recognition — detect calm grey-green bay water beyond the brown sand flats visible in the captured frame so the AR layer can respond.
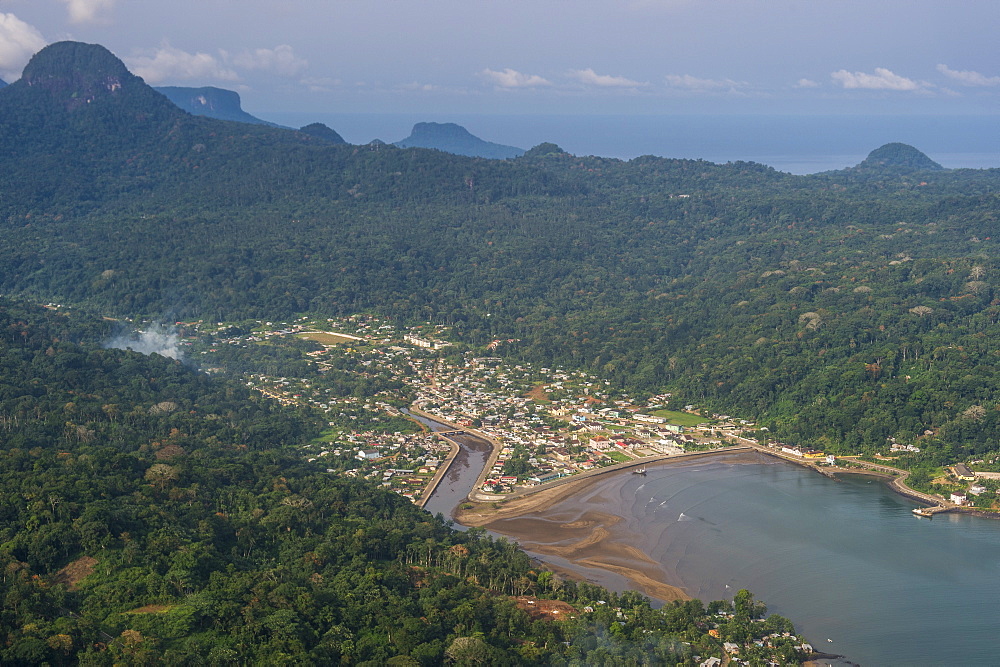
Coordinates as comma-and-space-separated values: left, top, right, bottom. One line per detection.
602, 459, 1000, 665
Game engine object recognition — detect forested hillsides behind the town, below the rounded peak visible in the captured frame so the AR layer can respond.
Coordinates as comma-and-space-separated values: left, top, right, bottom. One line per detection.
0, 40, 1000, 460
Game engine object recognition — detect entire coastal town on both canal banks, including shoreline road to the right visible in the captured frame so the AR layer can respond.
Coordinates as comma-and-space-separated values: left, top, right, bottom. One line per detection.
178, 315, 1000, 516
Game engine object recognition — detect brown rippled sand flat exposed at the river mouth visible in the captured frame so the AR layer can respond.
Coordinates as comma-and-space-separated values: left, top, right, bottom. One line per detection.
455, 453, 760, 601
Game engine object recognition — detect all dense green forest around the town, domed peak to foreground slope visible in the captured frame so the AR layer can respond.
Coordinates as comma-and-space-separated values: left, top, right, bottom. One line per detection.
0, 42, 1000, 665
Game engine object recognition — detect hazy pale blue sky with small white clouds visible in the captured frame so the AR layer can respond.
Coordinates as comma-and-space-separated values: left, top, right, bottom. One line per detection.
0, 0, 1000, 114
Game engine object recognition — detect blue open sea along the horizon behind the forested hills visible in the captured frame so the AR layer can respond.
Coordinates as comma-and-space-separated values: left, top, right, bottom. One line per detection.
256, 112, 1000, 174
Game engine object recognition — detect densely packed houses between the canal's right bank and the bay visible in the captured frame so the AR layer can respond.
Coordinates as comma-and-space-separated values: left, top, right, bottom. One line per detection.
410, 356, 746, 493
